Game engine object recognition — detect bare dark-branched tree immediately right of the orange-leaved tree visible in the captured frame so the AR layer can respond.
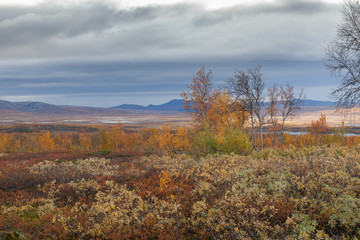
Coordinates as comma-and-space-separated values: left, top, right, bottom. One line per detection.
226, 66, 267, 148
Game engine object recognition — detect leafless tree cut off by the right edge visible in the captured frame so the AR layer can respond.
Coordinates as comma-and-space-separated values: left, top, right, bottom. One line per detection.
326, 0, 360, 112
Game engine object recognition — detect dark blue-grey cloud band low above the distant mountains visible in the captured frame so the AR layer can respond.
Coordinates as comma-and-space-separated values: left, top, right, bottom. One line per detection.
0, 59, 327, 106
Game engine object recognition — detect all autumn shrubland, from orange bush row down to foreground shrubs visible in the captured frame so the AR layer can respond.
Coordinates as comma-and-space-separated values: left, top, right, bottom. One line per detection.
0, 116, 360, 239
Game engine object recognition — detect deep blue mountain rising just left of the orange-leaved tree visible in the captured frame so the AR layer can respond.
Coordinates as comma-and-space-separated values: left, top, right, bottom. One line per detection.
112, 99, 185, 112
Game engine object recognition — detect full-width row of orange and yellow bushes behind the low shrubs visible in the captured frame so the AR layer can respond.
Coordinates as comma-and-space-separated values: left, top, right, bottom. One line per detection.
0, 119, 360, 156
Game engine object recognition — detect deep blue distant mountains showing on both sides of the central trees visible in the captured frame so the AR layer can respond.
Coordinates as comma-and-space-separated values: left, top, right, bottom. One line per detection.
112, 99, 336, 112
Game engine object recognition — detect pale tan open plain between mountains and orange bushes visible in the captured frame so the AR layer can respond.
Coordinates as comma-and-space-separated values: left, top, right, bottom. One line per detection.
0, 107, 360, 133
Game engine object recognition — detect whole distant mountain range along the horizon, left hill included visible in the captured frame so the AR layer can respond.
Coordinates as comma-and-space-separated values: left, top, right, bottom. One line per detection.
0, 99, 336, 115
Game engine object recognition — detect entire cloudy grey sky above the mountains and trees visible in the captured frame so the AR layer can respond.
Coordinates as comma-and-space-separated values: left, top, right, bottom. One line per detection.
0, 0, 343, 107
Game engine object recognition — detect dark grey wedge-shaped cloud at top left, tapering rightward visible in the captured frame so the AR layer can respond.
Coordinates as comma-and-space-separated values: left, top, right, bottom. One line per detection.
0, 2, 159, 47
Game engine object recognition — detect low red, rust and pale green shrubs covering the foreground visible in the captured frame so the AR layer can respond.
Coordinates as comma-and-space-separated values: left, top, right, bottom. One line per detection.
0, 145, 360, 239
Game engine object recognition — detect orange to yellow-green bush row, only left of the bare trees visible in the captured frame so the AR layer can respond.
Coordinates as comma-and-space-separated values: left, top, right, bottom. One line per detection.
0, 124, 251, 156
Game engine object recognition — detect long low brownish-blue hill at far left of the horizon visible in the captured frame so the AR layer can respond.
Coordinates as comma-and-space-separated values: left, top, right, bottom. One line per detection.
0, 100, 130, 115
